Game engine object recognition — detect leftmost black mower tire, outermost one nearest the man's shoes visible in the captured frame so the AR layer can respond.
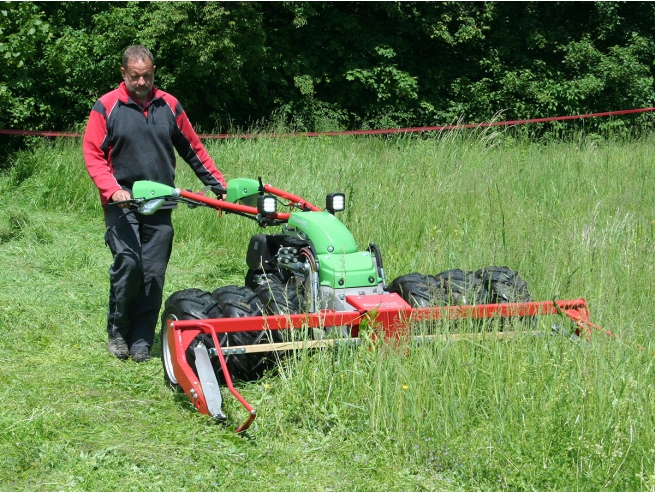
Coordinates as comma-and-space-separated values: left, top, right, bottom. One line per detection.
159, 289, 226, 391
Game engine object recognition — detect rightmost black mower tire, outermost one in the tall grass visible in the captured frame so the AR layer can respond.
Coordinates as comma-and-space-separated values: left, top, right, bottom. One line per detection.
475, 266, 532, 304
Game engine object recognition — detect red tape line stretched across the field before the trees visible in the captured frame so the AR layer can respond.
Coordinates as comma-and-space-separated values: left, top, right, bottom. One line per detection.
0, 107, 655, 139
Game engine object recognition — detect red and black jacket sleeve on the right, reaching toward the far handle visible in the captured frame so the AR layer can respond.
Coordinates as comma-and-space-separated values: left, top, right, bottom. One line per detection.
173, 101, 226, 188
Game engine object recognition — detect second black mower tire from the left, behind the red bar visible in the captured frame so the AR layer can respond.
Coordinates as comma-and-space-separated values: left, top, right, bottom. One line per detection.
211, 285, 282, 381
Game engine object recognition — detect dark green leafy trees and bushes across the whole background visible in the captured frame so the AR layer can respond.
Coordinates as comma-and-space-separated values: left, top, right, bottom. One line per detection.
0, 2, 655, 145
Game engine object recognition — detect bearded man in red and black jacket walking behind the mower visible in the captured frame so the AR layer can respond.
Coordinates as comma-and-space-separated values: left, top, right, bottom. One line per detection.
83, 45, 225, 362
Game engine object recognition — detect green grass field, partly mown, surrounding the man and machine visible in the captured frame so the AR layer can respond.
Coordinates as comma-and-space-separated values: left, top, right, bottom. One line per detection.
0, 133, 655, 491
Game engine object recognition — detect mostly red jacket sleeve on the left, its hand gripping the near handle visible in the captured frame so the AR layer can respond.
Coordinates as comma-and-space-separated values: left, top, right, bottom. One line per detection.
82, 101, 121, 205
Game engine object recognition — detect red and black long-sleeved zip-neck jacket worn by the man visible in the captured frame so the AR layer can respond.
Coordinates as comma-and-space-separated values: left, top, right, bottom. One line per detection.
83, 82, 225, 205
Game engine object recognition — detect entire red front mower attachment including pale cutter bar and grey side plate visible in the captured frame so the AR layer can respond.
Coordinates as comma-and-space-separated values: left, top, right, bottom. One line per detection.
164, 293, 598, 432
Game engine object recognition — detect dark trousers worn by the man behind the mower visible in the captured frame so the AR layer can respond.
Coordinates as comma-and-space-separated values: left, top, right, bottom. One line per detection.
105, 206, 173, 354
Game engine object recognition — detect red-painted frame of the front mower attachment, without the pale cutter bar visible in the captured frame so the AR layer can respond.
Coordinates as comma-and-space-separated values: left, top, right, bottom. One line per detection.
168, 294, 599, 432
